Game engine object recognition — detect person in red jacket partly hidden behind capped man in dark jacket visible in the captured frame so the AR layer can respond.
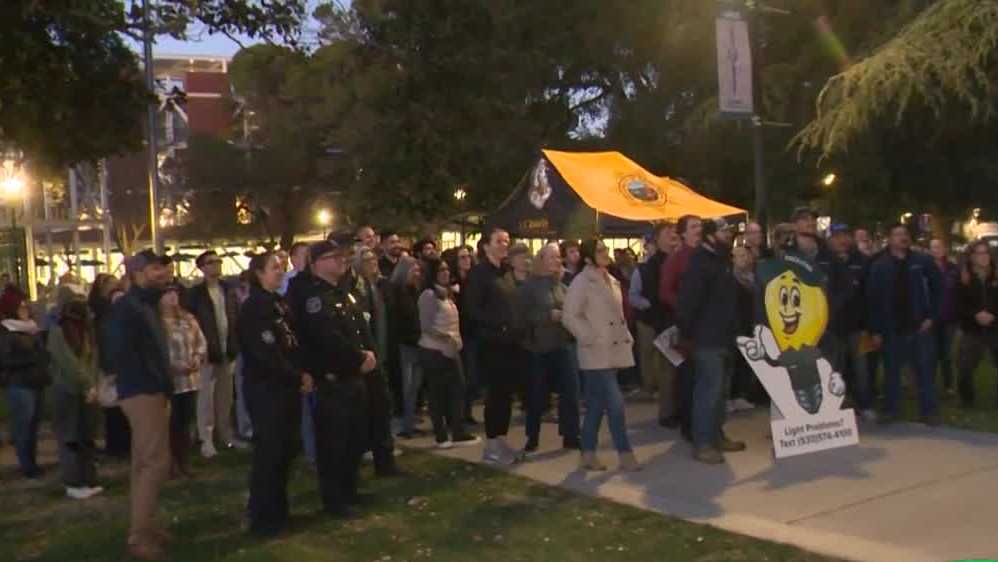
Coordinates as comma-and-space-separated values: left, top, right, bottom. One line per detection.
658, 215, 703, 440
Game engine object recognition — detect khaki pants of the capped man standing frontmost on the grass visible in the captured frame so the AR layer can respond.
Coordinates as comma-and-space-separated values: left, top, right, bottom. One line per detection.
121, 394, 170, 544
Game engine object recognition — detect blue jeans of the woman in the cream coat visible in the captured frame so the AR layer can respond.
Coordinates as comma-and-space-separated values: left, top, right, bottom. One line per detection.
582, 369, 631, 453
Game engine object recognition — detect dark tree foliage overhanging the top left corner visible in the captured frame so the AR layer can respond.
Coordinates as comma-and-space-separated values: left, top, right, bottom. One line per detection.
0, 0, 305, 169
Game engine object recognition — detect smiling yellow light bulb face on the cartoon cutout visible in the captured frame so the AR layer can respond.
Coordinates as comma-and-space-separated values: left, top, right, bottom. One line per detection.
765, 271, 828, 351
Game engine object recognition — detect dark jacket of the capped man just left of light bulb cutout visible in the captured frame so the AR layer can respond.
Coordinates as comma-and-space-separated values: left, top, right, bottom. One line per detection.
676, 243, 738, 349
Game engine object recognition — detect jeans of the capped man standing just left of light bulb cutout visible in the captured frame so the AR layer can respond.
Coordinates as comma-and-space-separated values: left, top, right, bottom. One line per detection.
691, 348, 733, 448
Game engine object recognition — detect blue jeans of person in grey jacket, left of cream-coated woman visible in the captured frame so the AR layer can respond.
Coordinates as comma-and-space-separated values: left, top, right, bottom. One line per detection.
527, 345, 579, 441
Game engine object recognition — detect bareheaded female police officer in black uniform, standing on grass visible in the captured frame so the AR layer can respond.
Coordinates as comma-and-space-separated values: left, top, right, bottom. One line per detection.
236, 252, 312, 536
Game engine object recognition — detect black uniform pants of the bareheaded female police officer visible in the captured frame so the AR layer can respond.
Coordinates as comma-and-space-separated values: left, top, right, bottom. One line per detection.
243, 379, 301, 535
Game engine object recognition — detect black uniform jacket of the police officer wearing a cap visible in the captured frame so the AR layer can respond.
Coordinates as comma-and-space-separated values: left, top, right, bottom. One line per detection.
295, 276, 375, 380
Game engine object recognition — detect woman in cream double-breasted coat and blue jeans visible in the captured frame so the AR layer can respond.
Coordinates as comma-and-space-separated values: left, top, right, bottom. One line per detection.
561, 240, 641, 471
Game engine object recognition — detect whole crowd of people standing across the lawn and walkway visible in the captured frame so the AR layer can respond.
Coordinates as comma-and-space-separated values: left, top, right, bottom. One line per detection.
0, 209, 998, 559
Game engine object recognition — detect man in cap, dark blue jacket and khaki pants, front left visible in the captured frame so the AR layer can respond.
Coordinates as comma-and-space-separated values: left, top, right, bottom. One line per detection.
109, 250, 173, 560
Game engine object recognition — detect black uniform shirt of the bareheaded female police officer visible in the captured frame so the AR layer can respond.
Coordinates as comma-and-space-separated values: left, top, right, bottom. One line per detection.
236, 287, 302, 388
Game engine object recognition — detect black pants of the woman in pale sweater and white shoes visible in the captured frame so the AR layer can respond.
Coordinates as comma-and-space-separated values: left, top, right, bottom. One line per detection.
419, 347, 465, 443
